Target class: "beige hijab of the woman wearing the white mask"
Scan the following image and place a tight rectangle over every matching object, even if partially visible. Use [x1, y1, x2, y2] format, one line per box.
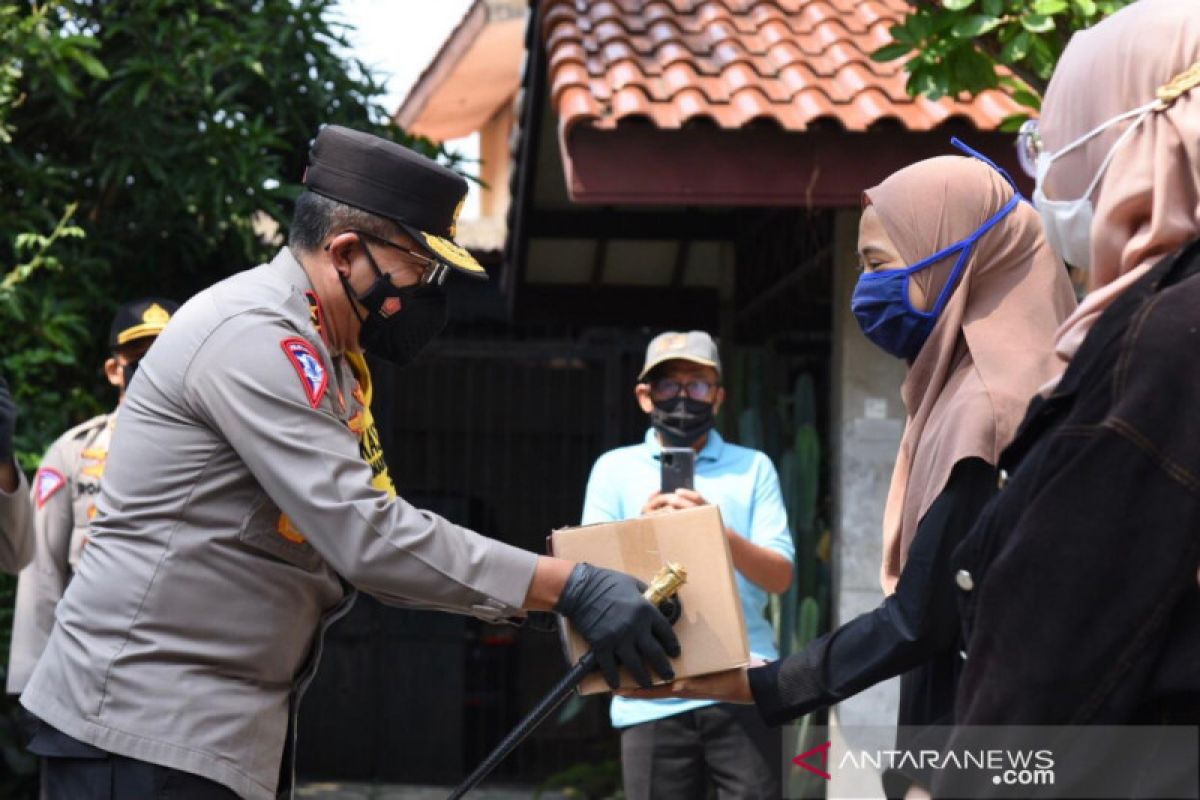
[1039, 0, 1200, 383]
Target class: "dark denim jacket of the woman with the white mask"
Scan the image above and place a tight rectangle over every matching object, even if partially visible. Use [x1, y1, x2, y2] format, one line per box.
[953, 240, 1200, 726]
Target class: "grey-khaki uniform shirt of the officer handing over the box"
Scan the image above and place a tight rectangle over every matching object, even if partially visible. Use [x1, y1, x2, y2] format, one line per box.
[22, 248, 536, 800]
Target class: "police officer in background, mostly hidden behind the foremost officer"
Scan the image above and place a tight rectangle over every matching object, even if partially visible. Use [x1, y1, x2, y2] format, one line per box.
[2, 297, 179, 694]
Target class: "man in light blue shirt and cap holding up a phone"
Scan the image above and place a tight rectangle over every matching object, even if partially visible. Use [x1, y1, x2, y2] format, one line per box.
[583, 331, 794, 800]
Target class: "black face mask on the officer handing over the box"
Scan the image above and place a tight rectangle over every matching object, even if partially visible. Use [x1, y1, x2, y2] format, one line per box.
[341, 239, 446, 367]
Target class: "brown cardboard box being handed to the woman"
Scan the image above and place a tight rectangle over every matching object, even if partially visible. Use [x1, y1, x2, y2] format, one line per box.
[550, 506, 750, 694]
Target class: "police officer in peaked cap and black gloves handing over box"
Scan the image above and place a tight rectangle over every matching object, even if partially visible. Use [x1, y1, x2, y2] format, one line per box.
[20, 127, 678, 800]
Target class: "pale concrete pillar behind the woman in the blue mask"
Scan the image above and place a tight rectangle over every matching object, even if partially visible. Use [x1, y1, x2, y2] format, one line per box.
[828, 210, 905, 798]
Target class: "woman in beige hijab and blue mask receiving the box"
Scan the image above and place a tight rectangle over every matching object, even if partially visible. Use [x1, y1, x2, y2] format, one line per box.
[632, 143, 1075, 795]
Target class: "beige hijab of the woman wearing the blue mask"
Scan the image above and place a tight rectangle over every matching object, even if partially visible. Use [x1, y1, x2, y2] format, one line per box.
[865, 156, 1075, 594]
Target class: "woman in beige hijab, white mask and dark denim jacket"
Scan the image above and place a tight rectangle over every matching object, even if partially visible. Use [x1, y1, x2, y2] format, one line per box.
[935, 0, 1200, 796]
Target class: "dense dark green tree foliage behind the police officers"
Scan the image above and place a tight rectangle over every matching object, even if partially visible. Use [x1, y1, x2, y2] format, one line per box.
[0, 0, 452, 468]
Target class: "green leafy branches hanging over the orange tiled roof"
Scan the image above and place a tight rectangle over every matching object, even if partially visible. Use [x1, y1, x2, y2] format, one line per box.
[871, 0, 1133, 128]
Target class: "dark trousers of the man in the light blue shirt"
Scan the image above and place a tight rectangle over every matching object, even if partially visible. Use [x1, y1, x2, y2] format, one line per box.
[620, 703, 782, 800]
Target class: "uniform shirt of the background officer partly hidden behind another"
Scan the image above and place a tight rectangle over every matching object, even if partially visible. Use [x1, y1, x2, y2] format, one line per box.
[7, 414, 116, 694]
